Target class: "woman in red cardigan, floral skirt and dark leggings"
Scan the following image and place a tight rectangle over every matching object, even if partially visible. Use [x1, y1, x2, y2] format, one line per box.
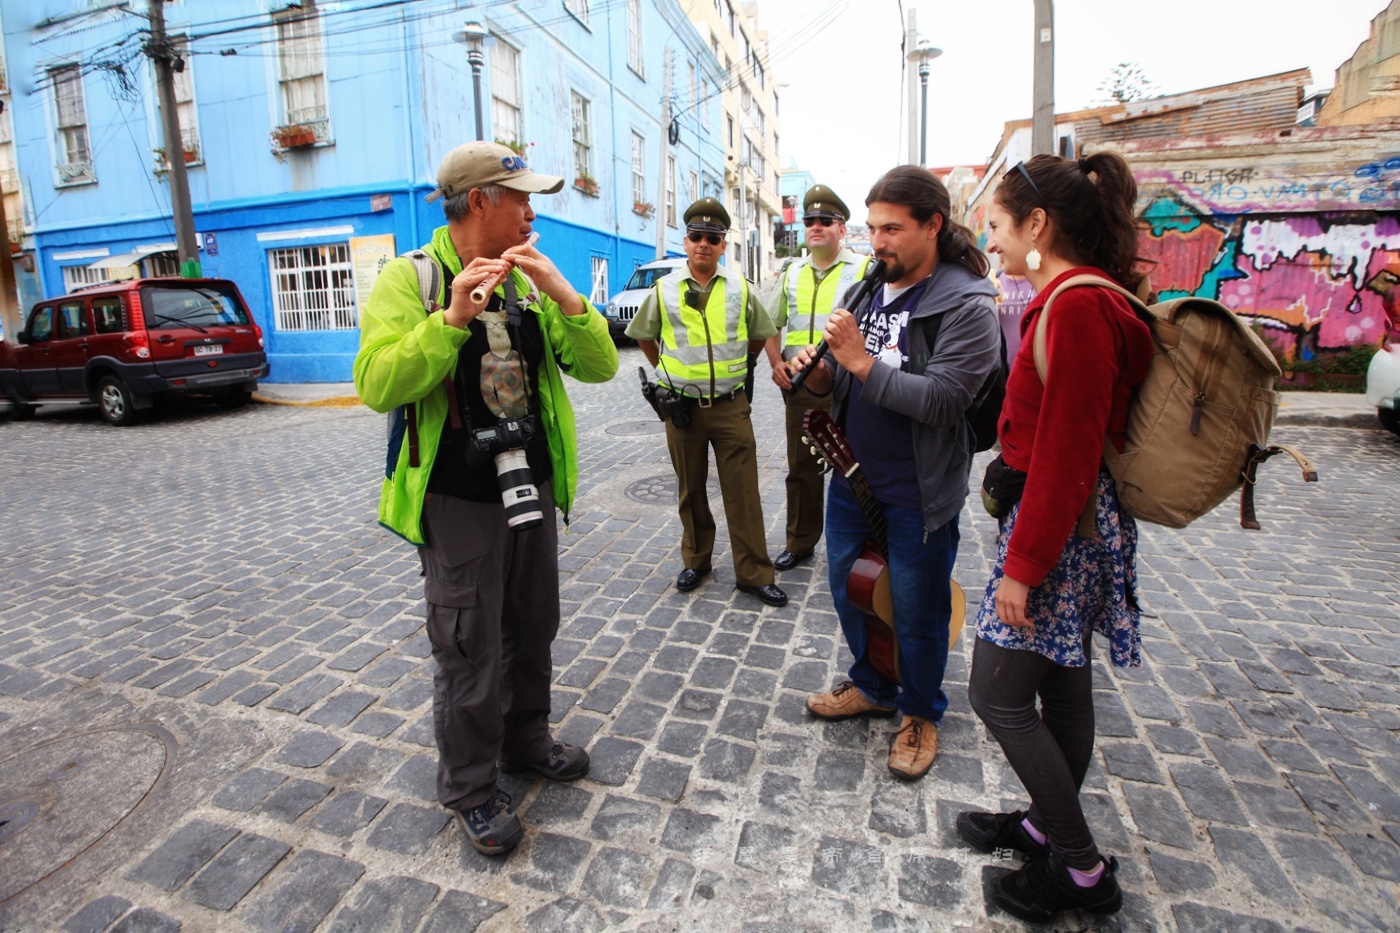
[958, 151, 1152, 922]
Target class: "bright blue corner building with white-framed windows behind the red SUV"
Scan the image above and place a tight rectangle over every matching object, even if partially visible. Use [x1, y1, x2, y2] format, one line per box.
[8, 0, 725, 382]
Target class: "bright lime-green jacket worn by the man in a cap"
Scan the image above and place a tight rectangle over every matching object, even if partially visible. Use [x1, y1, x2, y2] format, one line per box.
[354, 227, 617, 545]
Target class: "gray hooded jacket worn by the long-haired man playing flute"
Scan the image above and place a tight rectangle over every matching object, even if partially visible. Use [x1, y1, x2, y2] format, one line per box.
[832, 262, 1001, 531]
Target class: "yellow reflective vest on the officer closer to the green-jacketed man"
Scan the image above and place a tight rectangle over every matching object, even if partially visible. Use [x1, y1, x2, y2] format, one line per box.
[657, 266, 749, 398]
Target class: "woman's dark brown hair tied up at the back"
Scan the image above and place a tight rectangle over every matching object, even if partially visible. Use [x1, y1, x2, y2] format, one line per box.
[994, 150, 1151, 291]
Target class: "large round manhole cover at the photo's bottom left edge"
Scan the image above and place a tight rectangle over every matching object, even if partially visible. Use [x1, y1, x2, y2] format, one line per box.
[0, 727, 175, 902]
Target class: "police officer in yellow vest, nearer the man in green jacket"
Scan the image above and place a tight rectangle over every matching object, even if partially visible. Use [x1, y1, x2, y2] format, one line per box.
[627, 198, 787, 605]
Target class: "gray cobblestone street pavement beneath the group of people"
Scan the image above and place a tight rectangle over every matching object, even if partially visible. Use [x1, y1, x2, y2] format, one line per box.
[0, 349, 1400, 933]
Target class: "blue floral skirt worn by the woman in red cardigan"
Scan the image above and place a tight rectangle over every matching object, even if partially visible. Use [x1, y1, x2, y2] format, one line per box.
[977, 468, 1142, 667]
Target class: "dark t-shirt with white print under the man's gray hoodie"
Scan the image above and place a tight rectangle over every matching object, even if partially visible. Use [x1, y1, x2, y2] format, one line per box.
[837, 279, 928, 509]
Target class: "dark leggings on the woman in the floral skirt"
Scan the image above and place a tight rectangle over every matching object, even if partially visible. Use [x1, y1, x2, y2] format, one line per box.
[967, 639, 1100, 871]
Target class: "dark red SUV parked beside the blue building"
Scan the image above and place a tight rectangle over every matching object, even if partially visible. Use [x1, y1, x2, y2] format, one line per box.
[0, 279, 267, 426]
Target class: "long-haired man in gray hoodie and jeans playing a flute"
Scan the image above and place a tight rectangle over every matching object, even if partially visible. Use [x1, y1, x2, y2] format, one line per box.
[790, 165, 1001, 780]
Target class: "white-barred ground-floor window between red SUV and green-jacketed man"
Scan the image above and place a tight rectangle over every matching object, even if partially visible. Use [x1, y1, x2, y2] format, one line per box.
[267, 242, 360, 331]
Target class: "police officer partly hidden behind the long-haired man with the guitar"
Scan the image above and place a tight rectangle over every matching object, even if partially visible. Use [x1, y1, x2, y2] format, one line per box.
[767, 185, 869, 570]
